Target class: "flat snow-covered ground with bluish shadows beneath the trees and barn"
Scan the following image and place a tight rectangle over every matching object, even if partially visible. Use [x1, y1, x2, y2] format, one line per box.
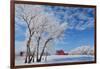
[15, 55, 94, 65]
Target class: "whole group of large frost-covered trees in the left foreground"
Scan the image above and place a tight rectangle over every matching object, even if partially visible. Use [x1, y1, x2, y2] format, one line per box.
[15, 4, 67, 63]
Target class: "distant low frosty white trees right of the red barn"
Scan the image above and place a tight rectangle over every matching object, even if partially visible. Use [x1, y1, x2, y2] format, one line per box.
[69, 46, 94, 55]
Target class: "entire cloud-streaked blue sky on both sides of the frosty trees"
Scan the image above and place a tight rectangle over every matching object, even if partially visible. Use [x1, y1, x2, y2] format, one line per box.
[15, 5, 95, 51]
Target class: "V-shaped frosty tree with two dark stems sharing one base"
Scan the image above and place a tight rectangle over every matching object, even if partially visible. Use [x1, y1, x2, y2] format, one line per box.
[28, 13, 67, 62]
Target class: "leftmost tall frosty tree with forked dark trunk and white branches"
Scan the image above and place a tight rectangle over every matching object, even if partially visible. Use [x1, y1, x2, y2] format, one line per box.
[15, 4, 43, 63]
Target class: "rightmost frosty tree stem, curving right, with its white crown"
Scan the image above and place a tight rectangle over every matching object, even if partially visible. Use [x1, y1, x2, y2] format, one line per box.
[39, 22, 67, 61]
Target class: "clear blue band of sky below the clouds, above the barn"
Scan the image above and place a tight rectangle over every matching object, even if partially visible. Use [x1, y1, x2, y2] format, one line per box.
[56, 29, 94, 51]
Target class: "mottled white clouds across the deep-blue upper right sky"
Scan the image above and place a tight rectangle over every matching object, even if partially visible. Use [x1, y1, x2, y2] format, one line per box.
[47, 6, 94, 30]
